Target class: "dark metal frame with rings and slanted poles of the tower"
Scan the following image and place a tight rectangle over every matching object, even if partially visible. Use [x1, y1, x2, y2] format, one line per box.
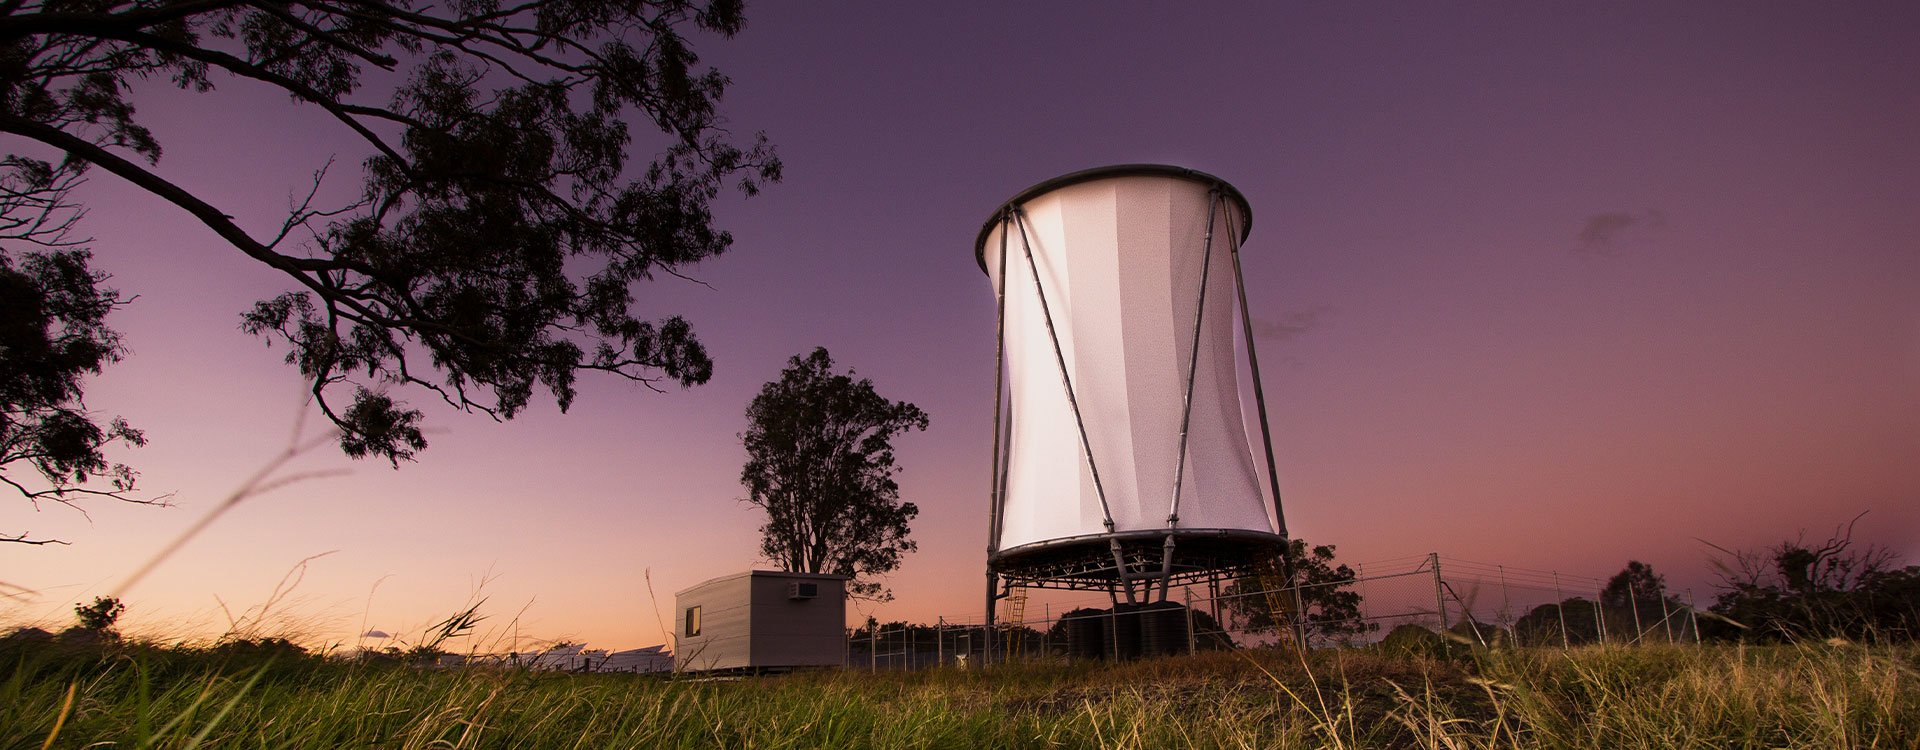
[973, 165, 1292, 640]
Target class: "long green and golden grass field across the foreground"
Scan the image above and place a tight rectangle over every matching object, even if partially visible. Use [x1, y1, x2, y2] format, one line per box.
[0, 641, 1920, 748]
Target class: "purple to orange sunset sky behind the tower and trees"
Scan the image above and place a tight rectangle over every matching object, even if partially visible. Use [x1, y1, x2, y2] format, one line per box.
[0, 2, 1920, 648]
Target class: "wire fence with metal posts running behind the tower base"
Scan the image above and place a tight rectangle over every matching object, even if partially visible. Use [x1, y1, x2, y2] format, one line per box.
[847, 554, 1699, 669]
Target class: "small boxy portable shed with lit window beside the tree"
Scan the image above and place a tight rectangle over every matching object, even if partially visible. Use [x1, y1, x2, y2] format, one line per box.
[674, 570, 847, 671]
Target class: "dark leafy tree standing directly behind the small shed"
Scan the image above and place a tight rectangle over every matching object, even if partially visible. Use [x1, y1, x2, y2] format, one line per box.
[739, 349, 927, 598]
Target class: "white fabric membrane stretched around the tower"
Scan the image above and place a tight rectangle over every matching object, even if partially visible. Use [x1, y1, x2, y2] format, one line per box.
[981, 175, 1273, 551]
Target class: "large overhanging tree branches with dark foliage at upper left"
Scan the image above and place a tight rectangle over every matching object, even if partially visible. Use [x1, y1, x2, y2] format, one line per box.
[0, 0, 780, 466]
